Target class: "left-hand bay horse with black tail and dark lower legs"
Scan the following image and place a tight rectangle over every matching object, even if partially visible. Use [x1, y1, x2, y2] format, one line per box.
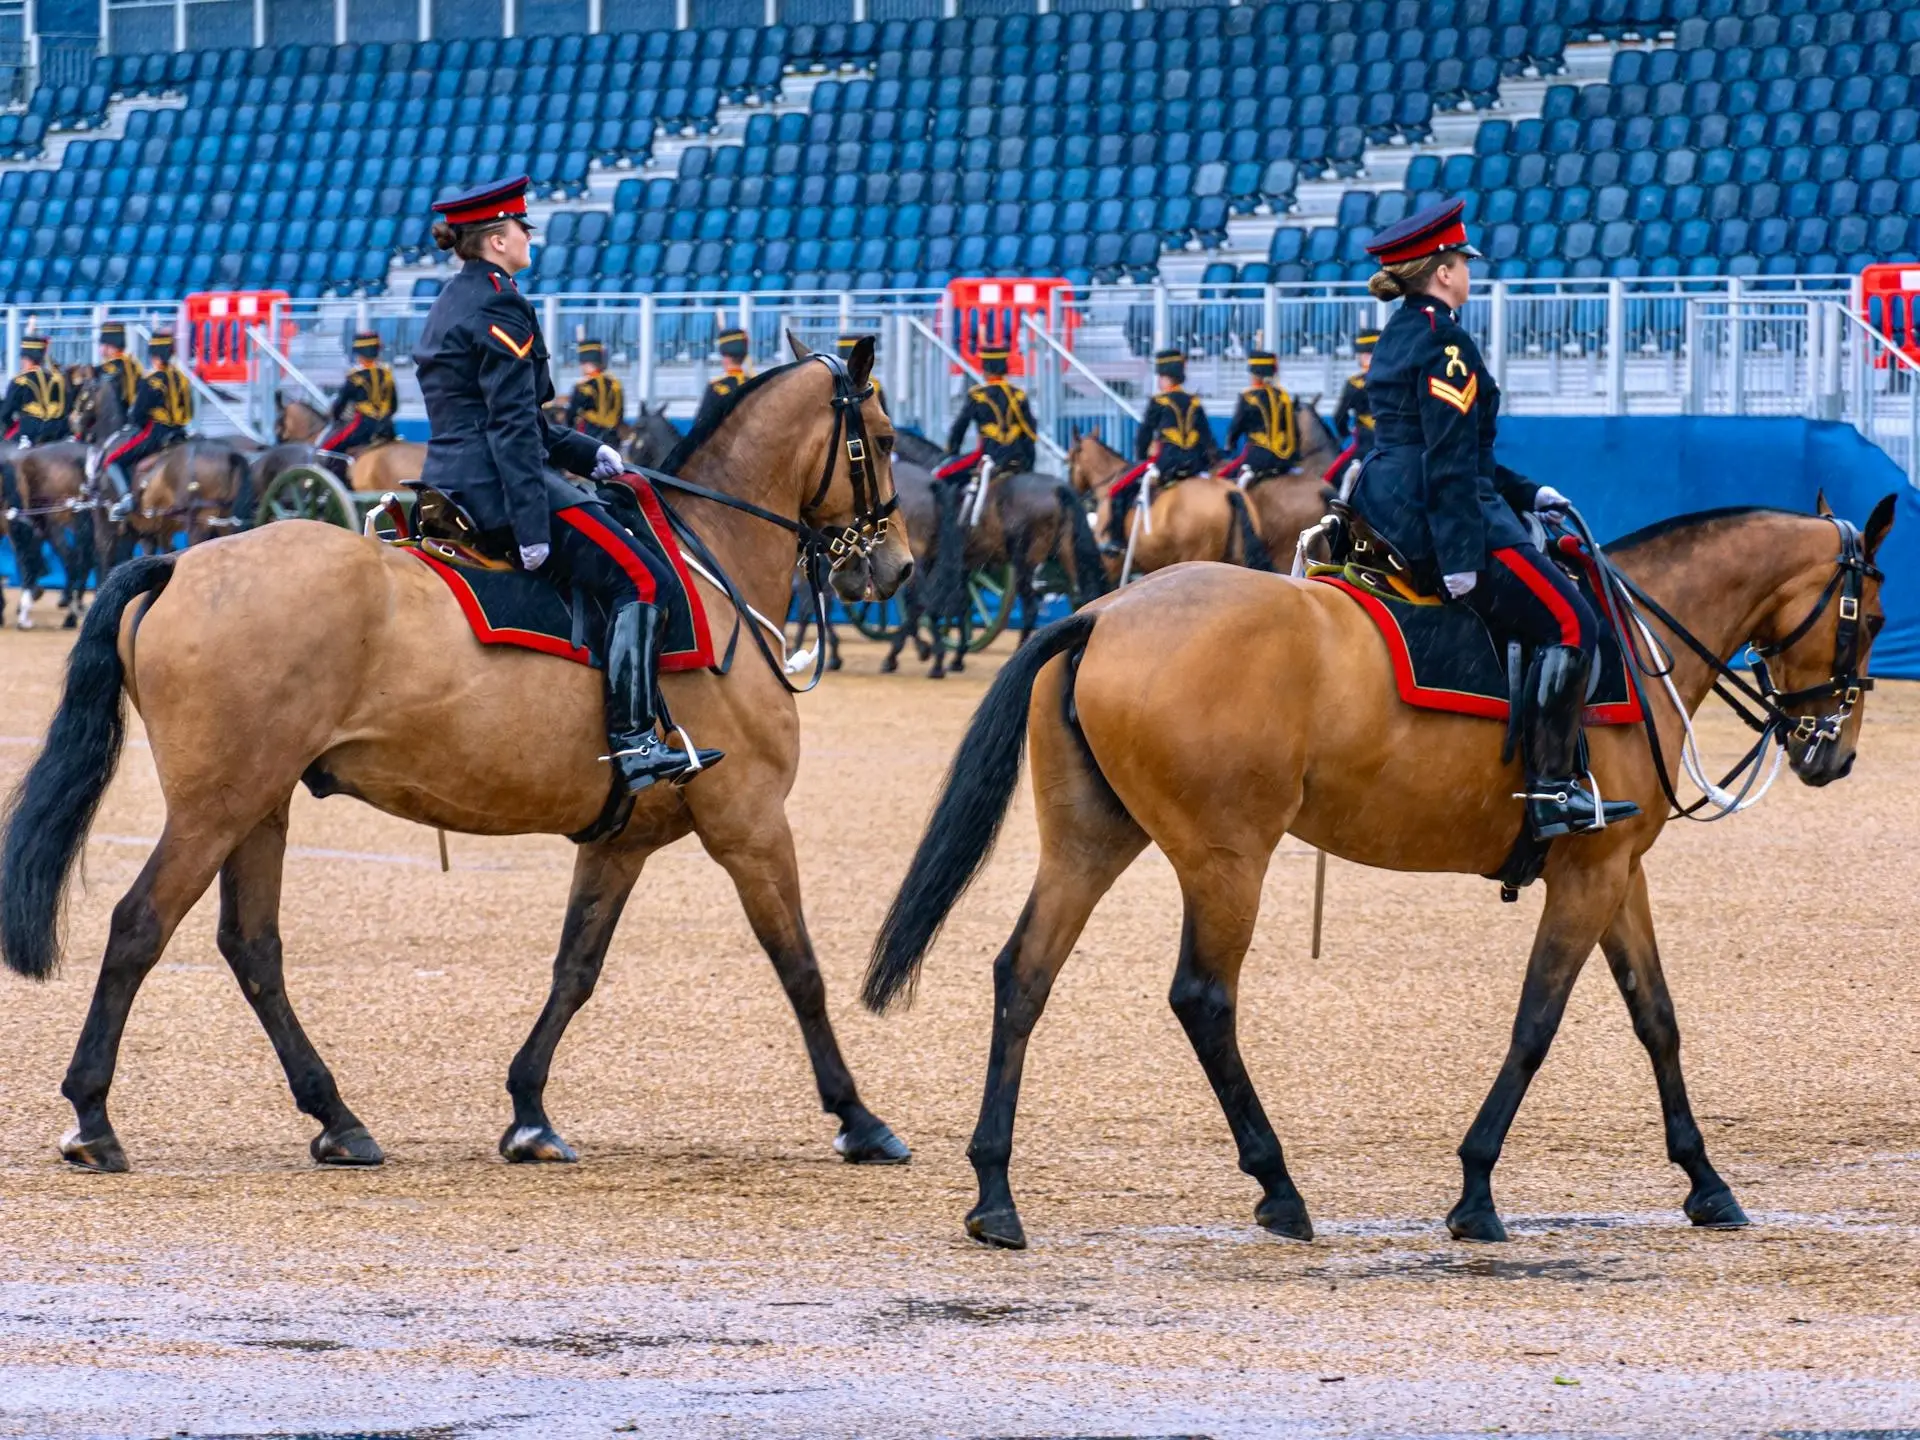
[0, 342, 910, 1171]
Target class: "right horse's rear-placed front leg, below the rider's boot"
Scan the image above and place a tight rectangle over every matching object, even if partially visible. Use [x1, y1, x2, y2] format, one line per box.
[1446, 856, 1626, 1240]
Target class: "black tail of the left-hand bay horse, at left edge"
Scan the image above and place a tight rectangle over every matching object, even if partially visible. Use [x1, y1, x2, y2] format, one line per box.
[0, 555, 173, 979]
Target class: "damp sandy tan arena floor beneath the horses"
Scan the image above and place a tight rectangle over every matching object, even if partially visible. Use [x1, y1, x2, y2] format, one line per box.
[0, 632, 1920, 1440]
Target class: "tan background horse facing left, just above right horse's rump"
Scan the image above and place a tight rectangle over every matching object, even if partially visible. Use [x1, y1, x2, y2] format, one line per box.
[1068, 432, 1274, 580]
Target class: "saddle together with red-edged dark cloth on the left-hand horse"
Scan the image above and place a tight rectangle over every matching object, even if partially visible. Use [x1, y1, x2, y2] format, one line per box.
[380, 478, 716, 674]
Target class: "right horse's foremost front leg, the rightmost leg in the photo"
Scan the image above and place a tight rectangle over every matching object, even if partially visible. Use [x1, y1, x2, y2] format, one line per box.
[1599, 866, 1747, 1229]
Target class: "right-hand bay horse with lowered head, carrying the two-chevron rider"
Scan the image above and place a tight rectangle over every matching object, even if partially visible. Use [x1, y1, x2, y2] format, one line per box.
[862, 495, 1893, 1248]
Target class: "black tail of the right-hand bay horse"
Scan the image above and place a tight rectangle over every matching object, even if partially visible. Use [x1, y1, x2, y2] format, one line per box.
[860, 612, 1094, 1012]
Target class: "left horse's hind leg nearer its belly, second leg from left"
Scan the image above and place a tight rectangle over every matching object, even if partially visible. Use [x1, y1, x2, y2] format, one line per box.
[219, 804, 386, 1165]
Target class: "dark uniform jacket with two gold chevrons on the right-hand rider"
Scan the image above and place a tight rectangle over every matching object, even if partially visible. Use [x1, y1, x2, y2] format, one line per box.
[1354, 296, 1538, 576]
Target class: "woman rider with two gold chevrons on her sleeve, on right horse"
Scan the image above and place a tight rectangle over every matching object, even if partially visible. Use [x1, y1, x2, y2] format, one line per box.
[1352, 200, 1640, 839]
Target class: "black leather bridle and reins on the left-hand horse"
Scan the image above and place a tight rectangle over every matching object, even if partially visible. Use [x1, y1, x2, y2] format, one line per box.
[632, 353, 900, 695]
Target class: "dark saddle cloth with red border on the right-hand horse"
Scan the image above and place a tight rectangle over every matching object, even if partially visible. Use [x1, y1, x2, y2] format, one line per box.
[1313, 536, 1642, 726]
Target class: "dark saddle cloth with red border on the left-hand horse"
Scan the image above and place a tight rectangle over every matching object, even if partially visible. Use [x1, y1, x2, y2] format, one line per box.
[403, 476, 714, 674]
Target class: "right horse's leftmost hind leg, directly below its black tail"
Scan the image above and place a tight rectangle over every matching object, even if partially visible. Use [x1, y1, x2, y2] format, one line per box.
[966, 814, 1146, 1250]
